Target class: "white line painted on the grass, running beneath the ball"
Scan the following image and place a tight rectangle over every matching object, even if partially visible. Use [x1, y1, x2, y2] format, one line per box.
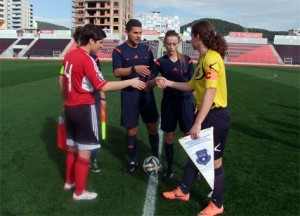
[143, 119, 163, 216]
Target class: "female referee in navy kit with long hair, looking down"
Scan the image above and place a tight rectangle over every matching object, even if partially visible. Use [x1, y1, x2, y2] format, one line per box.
[150, 30, 194, 180]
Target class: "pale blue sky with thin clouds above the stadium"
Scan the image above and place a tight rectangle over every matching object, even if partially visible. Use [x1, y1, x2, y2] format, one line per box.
[28, 0, 300, 31]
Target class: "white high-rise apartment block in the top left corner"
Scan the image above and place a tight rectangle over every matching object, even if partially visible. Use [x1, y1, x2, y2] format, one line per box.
[0, 0, 33, 31]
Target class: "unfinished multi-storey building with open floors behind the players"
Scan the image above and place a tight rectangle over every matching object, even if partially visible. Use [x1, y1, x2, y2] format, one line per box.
[73, 0, 134, 39]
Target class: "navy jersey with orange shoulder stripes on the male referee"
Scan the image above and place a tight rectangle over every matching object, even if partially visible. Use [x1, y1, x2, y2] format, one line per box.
[112, 42, 154, 81]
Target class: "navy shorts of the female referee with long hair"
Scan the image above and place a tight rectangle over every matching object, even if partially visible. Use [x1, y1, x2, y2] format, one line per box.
[161, 97, 195, 133]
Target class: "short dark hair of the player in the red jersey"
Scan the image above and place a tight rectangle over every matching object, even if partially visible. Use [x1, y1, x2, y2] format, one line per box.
[80, 23, 106, 46]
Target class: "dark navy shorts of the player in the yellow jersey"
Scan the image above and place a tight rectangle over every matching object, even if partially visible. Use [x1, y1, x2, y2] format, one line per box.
[201, 108, 230, 160]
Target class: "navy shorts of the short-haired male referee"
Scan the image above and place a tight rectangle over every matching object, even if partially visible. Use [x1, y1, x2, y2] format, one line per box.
[121, 88, 158, 128]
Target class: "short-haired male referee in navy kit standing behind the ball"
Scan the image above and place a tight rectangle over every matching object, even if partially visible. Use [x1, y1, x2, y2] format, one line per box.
[112, 19, 159, 174]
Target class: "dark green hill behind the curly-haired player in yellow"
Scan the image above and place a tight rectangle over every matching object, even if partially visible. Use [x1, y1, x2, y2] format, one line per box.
[180, 18, 288, 42]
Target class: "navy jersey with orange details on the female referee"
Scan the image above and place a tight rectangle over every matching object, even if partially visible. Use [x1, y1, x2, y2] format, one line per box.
[151, 55, 194, 99]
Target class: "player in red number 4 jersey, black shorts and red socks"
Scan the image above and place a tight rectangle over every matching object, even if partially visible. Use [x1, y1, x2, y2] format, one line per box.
[62, 24, 146, 200]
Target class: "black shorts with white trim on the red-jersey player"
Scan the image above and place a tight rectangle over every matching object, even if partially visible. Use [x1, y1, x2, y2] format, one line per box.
[65, 104, 100, 150]
